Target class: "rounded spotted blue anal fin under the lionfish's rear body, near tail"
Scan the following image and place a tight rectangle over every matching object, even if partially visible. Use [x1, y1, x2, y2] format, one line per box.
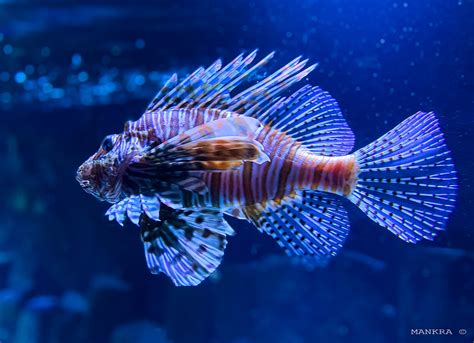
[243, 191, 349, 259]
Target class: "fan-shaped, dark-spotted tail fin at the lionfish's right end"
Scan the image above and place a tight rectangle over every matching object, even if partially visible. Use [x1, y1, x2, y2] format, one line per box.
[349, 112, 457, 243]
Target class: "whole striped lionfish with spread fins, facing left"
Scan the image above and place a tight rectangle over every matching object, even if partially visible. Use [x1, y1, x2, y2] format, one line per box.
[77, 51, 457, 286]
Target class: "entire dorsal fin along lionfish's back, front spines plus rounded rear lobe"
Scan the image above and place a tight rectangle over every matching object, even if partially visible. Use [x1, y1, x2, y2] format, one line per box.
[147, 51, 354, 156]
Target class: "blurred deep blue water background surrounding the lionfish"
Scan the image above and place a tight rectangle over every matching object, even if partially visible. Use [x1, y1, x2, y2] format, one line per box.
[0, 0, 474, 343]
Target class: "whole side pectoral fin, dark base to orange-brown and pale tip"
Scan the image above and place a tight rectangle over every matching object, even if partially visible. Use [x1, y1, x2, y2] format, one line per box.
[126, 117, 269, 200]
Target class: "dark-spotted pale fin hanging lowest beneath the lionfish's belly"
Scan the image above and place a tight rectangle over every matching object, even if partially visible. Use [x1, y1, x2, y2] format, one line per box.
[140, 206, 234, 286]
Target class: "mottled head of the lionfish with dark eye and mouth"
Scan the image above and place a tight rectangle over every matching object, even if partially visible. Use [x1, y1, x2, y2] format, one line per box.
[76, 135, 130, 203]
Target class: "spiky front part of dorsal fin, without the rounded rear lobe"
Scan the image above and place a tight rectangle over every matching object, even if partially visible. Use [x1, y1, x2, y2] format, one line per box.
[147, 50, 315, 116]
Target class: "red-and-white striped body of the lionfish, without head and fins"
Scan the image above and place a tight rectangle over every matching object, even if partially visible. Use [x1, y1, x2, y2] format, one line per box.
[126, 109, 357, 209]
